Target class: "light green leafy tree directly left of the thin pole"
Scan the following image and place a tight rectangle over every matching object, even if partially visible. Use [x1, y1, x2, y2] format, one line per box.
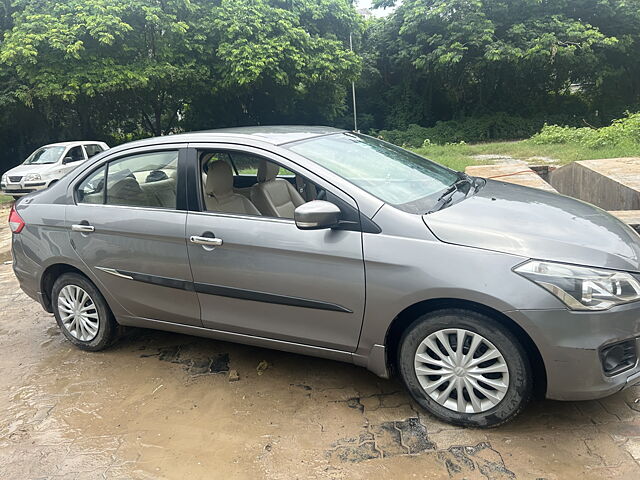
[182, 0, 360, 128]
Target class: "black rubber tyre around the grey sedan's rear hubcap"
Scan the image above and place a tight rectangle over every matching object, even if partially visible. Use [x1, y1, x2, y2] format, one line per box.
[51, 273, 118, 352]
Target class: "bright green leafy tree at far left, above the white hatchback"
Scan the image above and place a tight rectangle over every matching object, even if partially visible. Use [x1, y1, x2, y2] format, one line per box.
[0, 0, 208, 136]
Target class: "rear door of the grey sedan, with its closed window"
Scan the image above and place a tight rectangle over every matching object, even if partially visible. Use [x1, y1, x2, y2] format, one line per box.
[66, 145, 201, 326]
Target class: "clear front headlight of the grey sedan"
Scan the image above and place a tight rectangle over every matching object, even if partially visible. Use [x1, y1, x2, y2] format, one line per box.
[513, 260, 640, 310]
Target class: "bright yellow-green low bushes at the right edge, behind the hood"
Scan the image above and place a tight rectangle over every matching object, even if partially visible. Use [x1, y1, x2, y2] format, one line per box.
[531, 112, 640, 149]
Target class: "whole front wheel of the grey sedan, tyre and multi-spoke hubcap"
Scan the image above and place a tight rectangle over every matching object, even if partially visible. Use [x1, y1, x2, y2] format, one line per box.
[398, 309, 532, 427]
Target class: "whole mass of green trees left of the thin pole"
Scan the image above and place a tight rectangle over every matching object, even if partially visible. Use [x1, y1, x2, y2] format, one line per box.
[0, 0, 362, 171]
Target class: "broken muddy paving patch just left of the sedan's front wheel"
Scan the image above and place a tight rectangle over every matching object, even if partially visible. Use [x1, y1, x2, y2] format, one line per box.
[326, 418, 436, 462]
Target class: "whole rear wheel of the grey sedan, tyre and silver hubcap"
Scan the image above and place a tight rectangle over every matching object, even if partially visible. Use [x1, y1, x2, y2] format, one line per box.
[51, 273, 118, 351]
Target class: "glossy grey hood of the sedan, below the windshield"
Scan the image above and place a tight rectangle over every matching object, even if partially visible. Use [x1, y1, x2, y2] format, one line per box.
[423, 180, 640, 271]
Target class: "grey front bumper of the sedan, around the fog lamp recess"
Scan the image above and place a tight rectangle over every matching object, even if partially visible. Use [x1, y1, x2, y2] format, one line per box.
[505, 303, 640, 400]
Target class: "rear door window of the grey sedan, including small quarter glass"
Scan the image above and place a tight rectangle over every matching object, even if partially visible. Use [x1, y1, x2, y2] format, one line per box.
[76, 151, 178, 209]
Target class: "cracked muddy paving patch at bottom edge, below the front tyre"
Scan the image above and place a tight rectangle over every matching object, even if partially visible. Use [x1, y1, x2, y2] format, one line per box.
[438, 442, 516, 480]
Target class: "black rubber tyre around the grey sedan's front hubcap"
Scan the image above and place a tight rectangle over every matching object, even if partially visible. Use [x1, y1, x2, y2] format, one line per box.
[398, 309, 533, 428]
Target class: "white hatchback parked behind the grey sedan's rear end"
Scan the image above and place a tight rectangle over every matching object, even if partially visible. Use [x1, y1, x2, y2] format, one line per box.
[0, 141, 109, 198]
